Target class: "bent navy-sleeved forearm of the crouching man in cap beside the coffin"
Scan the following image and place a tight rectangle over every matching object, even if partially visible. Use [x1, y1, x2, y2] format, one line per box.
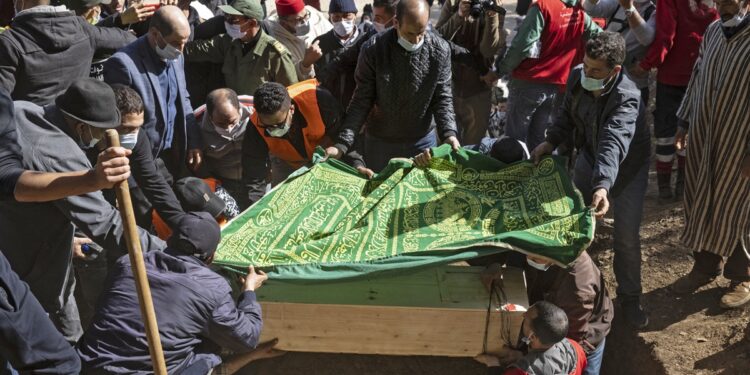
[206, 291, 263, 352]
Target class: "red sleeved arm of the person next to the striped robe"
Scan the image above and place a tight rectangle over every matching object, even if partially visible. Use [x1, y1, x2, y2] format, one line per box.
[640, 0, 677, 71]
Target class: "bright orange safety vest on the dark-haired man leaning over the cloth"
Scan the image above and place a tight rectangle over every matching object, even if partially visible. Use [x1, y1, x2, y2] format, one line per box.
[250, 79, 326, 168]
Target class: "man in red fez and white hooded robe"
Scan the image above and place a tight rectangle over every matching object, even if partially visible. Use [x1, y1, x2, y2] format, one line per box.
[263, 0, 333, 81]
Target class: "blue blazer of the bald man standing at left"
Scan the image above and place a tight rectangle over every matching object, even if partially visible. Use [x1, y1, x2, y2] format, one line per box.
[104, 35, 201, 159]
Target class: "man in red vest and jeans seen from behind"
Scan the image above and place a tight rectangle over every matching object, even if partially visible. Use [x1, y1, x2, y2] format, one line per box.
[486, 0, 601, 149]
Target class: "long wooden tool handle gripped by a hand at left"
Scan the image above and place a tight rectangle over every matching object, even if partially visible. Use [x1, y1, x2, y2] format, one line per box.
[106, 129, 167, 375]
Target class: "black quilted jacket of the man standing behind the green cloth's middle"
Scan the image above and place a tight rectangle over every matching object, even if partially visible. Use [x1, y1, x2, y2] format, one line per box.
[336, 29, 456, 151]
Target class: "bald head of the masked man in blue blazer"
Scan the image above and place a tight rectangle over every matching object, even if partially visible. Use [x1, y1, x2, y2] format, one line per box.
[148, 5, 190, 51]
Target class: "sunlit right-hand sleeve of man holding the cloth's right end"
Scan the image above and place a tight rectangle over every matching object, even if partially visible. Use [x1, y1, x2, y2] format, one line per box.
[591, 92, 640, 191]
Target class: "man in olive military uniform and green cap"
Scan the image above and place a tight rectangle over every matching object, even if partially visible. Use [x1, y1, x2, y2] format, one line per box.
[185, 0, 297, 95]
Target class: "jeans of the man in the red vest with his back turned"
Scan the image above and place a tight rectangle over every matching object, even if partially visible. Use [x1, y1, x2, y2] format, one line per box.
[505, 80, 559, 151]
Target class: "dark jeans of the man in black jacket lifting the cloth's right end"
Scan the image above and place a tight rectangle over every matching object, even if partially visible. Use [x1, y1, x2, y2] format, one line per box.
[573, 152, 649, 298]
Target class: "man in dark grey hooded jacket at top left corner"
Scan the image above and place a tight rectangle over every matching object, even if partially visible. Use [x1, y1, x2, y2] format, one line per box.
[0, 0, 135, 105]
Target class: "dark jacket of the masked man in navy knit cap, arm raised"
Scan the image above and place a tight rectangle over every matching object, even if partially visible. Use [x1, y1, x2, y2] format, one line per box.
[313, 27, 374, 108]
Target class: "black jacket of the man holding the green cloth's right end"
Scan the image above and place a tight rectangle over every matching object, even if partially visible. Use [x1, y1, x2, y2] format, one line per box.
[547, 65, 651, 195]
